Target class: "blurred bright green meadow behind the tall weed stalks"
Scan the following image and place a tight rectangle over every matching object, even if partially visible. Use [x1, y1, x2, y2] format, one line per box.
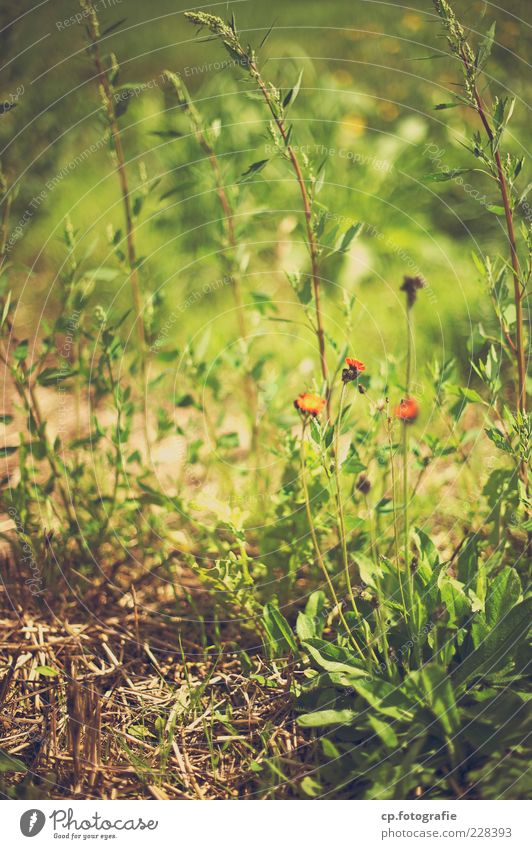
[0, 0, 532, 384]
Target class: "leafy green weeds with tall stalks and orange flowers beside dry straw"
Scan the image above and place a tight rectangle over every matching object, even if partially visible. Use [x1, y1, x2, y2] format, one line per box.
[0, 0, 532, 799]
